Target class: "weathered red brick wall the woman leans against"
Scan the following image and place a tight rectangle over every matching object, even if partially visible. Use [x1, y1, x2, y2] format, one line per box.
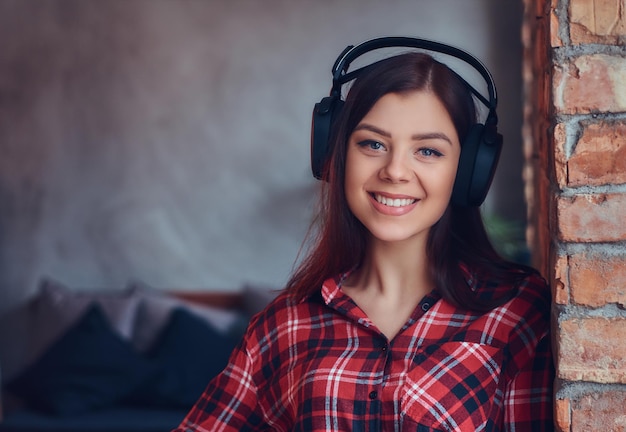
[522, 0, 626, 432]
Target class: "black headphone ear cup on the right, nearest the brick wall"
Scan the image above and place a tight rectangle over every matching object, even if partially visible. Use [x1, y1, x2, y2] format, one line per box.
[452, 123, 502, 207]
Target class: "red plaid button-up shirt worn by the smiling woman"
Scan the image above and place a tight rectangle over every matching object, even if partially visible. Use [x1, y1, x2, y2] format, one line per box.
[175, 268, 554, 432]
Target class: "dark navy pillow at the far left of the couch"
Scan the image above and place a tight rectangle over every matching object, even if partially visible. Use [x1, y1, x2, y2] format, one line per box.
[8, 304, 154, 416]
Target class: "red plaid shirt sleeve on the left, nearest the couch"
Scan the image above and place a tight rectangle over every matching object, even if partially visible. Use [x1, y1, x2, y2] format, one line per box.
[172, 339, 262, 432]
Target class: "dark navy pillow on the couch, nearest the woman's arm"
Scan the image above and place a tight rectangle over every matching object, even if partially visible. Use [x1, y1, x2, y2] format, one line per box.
[131, 308, 239, 409]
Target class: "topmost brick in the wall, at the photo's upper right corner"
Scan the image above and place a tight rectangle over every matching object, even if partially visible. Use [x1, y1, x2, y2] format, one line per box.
[569, 0, 626, 45]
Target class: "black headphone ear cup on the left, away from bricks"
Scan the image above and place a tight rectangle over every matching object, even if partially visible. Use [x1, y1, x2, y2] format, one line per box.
[311, 95, 344, 180]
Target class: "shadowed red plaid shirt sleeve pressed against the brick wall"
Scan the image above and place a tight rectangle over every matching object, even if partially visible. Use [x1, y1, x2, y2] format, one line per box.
[504, 318, 555, 432]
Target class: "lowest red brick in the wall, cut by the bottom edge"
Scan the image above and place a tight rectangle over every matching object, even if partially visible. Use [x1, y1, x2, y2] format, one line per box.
[571, 391, 626, 432]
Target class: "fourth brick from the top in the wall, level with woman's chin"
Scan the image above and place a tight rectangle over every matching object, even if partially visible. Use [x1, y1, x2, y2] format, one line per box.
[557, 193, 626, 242]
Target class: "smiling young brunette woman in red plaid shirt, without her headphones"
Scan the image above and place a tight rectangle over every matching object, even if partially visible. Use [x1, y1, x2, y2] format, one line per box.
[176, 38, 553, 432]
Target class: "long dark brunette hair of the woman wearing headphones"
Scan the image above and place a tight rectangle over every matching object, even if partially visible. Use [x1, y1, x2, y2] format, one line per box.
[286, 52, 529, 311]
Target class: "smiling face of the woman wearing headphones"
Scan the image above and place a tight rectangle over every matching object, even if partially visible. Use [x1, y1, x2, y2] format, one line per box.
[345, 91, 461, 244]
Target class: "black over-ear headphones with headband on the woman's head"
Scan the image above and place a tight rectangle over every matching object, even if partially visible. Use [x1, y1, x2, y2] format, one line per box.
[311, 37, 502, 206]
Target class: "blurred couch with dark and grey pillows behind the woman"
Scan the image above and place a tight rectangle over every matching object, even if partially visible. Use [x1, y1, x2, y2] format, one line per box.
[0, 279, 275, 432]
